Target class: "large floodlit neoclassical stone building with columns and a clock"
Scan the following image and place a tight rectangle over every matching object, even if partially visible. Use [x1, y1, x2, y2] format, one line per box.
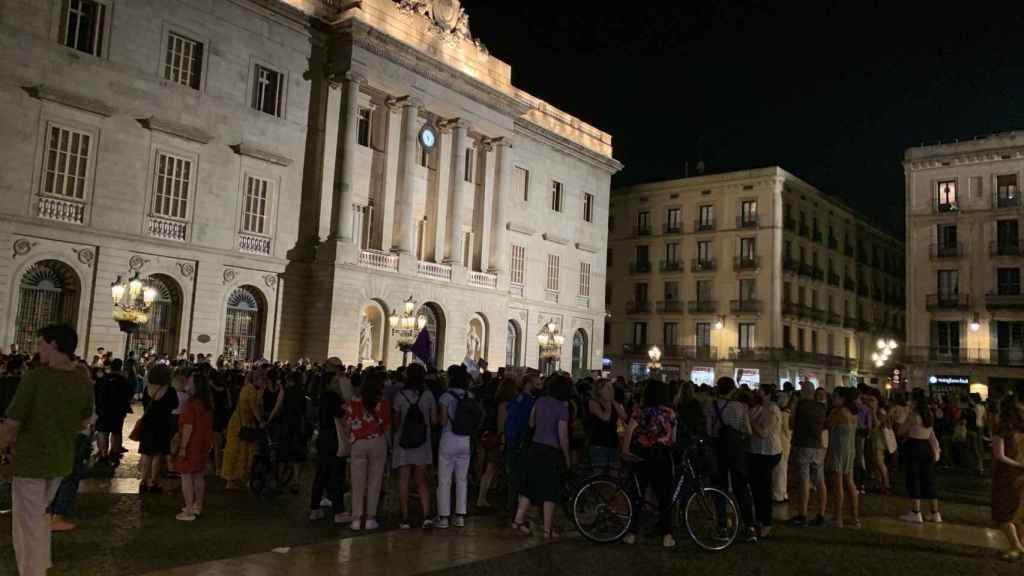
[0, 0, 621, 368]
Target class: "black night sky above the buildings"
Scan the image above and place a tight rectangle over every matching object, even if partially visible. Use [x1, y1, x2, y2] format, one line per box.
[463, 0, 1024, 233]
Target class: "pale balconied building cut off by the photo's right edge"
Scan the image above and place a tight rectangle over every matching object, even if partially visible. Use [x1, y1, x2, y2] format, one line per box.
[903, 132, 1024, 396]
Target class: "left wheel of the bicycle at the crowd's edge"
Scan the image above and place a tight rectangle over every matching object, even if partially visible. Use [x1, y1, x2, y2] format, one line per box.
[571, 479, 633, 544]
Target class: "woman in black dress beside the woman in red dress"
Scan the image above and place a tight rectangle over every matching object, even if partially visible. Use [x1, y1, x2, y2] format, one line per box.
[138, 364, 178, 494]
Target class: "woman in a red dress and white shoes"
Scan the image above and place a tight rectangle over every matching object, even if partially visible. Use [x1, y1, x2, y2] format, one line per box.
[175, 371, 213, 522]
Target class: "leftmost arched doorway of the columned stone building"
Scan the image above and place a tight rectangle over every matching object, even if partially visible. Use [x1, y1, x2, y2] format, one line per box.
[14, 260, 81, 354]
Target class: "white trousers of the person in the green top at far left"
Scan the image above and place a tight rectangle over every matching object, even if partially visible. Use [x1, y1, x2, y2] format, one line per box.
[11, 477, 60, 576]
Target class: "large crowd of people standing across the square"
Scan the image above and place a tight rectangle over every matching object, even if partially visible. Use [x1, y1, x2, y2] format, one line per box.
[0, 327, 1024, 574]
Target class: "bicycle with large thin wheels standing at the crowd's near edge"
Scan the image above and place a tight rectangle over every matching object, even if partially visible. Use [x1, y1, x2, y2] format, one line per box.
[570, 443, 741, 551]
